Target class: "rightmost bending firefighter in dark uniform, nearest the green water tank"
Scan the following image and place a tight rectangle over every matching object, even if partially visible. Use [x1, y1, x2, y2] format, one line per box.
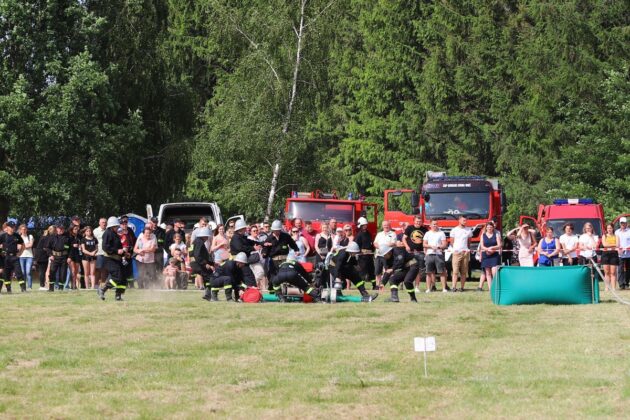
[381, 242, 420, 303]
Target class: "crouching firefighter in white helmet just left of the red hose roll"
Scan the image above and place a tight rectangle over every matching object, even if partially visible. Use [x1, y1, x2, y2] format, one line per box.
[210, 252, 256, 302]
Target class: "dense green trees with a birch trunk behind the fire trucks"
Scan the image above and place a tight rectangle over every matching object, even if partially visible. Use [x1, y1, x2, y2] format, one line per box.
[0, 0, 630, 222]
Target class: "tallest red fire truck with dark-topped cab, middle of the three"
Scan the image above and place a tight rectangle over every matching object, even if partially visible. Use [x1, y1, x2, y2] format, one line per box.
[384, 171, 506, 242]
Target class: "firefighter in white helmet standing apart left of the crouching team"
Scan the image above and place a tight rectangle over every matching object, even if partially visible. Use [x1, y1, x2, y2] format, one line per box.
[97, 216, 129, 301]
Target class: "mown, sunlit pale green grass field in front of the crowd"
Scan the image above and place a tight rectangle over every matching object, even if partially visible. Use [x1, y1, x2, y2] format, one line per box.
[0, 290, 630, 418]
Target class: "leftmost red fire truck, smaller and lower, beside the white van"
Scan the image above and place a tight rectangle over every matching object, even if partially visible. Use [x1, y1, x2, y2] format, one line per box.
[284, 190, 378, 237]
